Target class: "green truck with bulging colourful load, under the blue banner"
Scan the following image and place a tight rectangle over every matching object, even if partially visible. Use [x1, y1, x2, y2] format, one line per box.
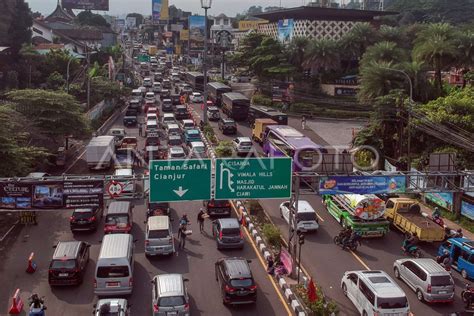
[323, 194, 390, 237]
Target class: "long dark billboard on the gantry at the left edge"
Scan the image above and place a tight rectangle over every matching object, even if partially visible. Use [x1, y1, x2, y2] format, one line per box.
[0, 180, 104, 210]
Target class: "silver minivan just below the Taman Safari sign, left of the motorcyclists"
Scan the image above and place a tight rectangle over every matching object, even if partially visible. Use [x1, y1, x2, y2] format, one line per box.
[145, 215, 175, 256]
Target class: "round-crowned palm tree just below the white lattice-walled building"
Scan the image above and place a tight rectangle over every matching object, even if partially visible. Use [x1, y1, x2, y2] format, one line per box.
[303, 39, 341, 80]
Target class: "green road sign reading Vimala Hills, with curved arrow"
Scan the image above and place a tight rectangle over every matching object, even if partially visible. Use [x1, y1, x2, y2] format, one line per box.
[215, 158, 292, 199]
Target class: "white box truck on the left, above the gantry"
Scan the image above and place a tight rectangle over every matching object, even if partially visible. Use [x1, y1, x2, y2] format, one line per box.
[86, 136, 115, 170]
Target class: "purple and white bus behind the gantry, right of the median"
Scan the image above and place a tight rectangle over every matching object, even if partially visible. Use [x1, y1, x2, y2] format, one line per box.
[262, 125, 327, 172]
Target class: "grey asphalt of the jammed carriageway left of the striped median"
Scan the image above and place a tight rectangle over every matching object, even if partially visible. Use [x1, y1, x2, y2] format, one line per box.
[0, 87, 288, 316]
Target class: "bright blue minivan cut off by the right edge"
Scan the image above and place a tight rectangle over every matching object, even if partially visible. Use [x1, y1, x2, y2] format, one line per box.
[438, 238, 474, 279]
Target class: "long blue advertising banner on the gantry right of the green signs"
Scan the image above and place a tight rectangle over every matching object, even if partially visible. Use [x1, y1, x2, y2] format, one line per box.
[319, 176, 405, 194]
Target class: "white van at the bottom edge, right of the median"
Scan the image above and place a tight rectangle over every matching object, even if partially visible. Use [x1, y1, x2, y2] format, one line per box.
[341, 270, 410, 316]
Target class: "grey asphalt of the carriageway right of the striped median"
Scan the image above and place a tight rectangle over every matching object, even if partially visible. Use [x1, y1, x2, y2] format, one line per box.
[187, 100, 465, 315]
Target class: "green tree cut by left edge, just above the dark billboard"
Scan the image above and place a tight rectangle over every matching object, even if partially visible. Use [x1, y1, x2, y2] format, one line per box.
[0, 105, 47, 177]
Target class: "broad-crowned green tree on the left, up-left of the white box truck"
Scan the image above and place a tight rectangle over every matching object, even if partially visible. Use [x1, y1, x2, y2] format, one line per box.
[6, 89, 89, 143]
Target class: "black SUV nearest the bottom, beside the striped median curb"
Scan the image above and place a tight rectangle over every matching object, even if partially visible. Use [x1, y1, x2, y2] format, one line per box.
[215, 257, 257, 304]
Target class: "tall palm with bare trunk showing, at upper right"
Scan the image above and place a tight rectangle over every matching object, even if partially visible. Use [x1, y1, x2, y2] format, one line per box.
[413, 23, 459, 93]
